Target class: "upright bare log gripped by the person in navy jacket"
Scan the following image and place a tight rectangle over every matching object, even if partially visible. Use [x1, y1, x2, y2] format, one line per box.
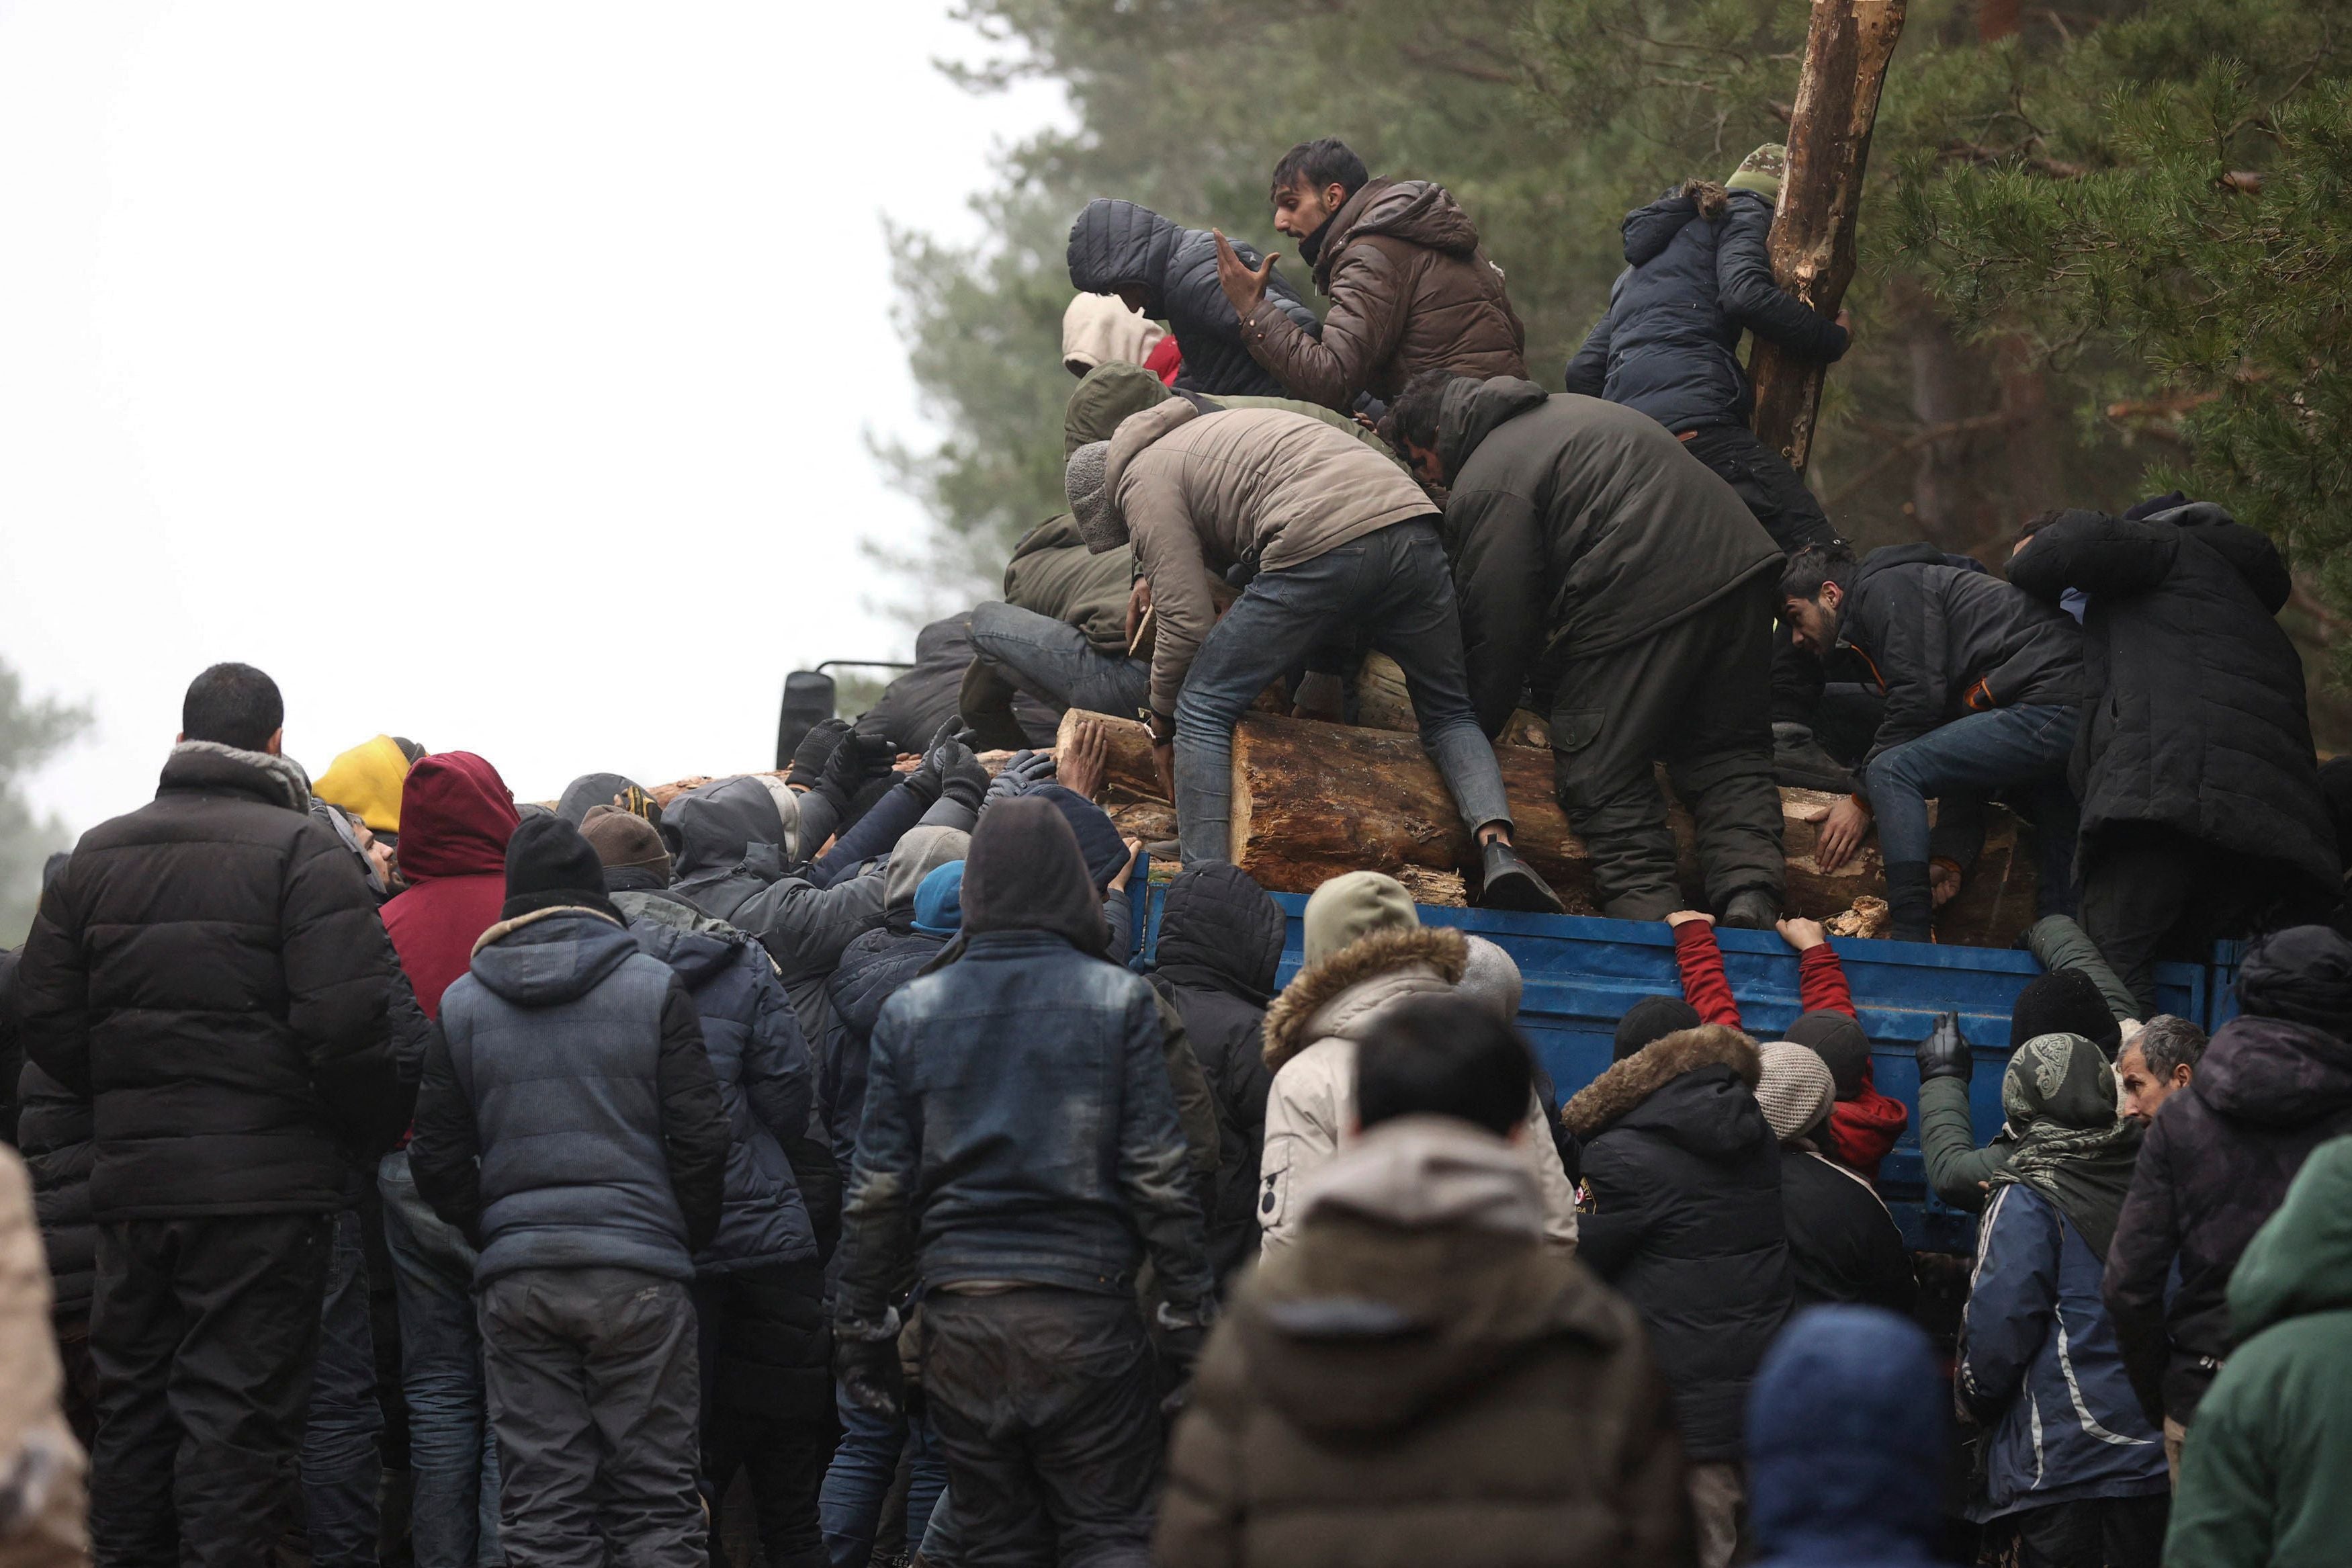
[1747, 0, 1903, 472]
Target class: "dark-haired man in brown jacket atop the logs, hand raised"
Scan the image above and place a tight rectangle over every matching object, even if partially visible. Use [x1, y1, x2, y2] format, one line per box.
[1216, 136, 1526, 409]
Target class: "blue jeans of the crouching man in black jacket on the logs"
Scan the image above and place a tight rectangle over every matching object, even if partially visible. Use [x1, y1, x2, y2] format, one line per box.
[1863, 705, 2081, 914]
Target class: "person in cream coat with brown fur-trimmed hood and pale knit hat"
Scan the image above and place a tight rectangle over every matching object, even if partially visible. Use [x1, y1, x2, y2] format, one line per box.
[1258, 872, 1576, 1251]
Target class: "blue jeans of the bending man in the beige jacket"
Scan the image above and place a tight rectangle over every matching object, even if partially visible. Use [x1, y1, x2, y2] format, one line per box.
[1176, 519, 1510, 865]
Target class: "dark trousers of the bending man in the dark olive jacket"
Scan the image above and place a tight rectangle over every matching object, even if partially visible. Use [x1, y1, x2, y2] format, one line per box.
[1553, 578, 1788, 919]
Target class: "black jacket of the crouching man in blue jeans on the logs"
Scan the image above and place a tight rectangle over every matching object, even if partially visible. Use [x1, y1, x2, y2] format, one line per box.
[1839, 546, 2091, 762]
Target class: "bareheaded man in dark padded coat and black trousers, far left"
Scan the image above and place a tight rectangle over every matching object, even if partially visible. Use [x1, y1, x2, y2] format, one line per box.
[19, 665, 407, 1566]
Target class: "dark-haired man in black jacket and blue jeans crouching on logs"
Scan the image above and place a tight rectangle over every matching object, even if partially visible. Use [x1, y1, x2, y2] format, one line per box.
[1780, 546, 2091, 943]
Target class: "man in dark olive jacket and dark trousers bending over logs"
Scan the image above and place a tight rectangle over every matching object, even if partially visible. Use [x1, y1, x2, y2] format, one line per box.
[1383, 372, 1788, 931]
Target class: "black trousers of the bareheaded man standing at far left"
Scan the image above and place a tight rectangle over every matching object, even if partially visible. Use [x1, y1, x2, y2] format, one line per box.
[89, 1213, 334, 1568]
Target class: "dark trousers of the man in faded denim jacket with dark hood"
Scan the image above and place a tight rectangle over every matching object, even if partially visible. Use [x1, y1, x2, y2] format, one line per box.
[922, 1289, 1160, 1568]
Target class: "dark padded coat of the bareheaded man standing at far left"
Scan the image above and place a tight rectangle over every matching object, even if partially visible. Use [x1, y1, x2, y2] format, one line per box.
[17, 740, 404, 1223]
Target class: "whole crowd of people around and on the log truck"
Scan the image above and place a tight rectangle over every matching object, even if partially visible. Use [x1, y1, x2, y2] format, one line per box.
[0, 141, 2352, 1568]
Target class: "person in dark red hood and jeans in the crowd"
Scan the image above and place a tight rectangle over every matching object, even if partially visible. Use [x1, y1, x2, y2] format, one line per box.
[376, 752, 520, 1568]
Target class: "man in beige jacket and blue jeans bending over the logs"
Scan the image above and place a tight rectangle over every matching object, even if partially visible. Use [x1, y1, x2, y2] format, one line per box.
[1065, 400, 1561, 914]
